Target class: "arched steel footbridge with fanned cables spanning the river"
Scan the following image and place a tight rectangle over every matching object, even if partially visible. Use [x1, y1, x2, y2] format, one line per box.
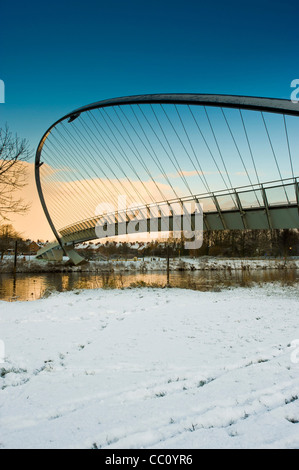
[35, 94, 299, 264]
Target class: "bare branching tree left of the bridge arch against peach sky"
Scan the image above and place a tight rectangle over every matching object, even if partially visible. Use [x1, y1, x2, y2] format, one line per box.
[0, 125, 31, 221]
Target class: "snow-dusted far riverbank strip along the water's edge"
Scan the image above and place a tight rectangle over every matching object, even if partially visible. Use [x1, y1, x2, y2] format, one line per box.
[0, 257, 299, 274]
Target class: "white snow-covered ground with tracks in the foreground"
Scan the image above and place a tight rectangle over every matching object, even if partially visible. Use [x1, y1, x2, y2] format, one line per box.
[0, 284, 299, 449]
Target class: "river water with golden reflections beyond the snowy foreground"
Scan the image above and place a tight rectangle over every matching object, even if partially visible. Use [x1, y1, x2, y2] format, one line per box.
[0, 269, 299, 302]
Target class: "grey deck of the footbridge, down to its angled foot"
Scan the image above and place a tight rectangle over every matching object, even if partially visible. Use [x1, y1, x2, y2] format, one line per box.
[37, 180, 299, 264]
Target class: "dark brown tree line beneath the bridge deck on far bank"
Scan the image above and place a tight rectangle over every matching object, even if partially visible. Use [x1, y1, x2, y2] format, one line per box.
[80, 229, 299, 259]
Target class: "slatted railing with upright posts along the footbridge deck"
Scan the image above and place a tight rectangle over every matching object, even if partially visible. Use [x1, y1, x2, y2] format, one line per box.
[59, 177, 299, 236]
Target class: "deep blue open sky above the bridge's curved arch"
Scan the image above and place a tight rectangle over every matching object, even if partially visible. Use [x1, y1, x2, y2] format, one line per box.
[0, 0, 299, 151]
